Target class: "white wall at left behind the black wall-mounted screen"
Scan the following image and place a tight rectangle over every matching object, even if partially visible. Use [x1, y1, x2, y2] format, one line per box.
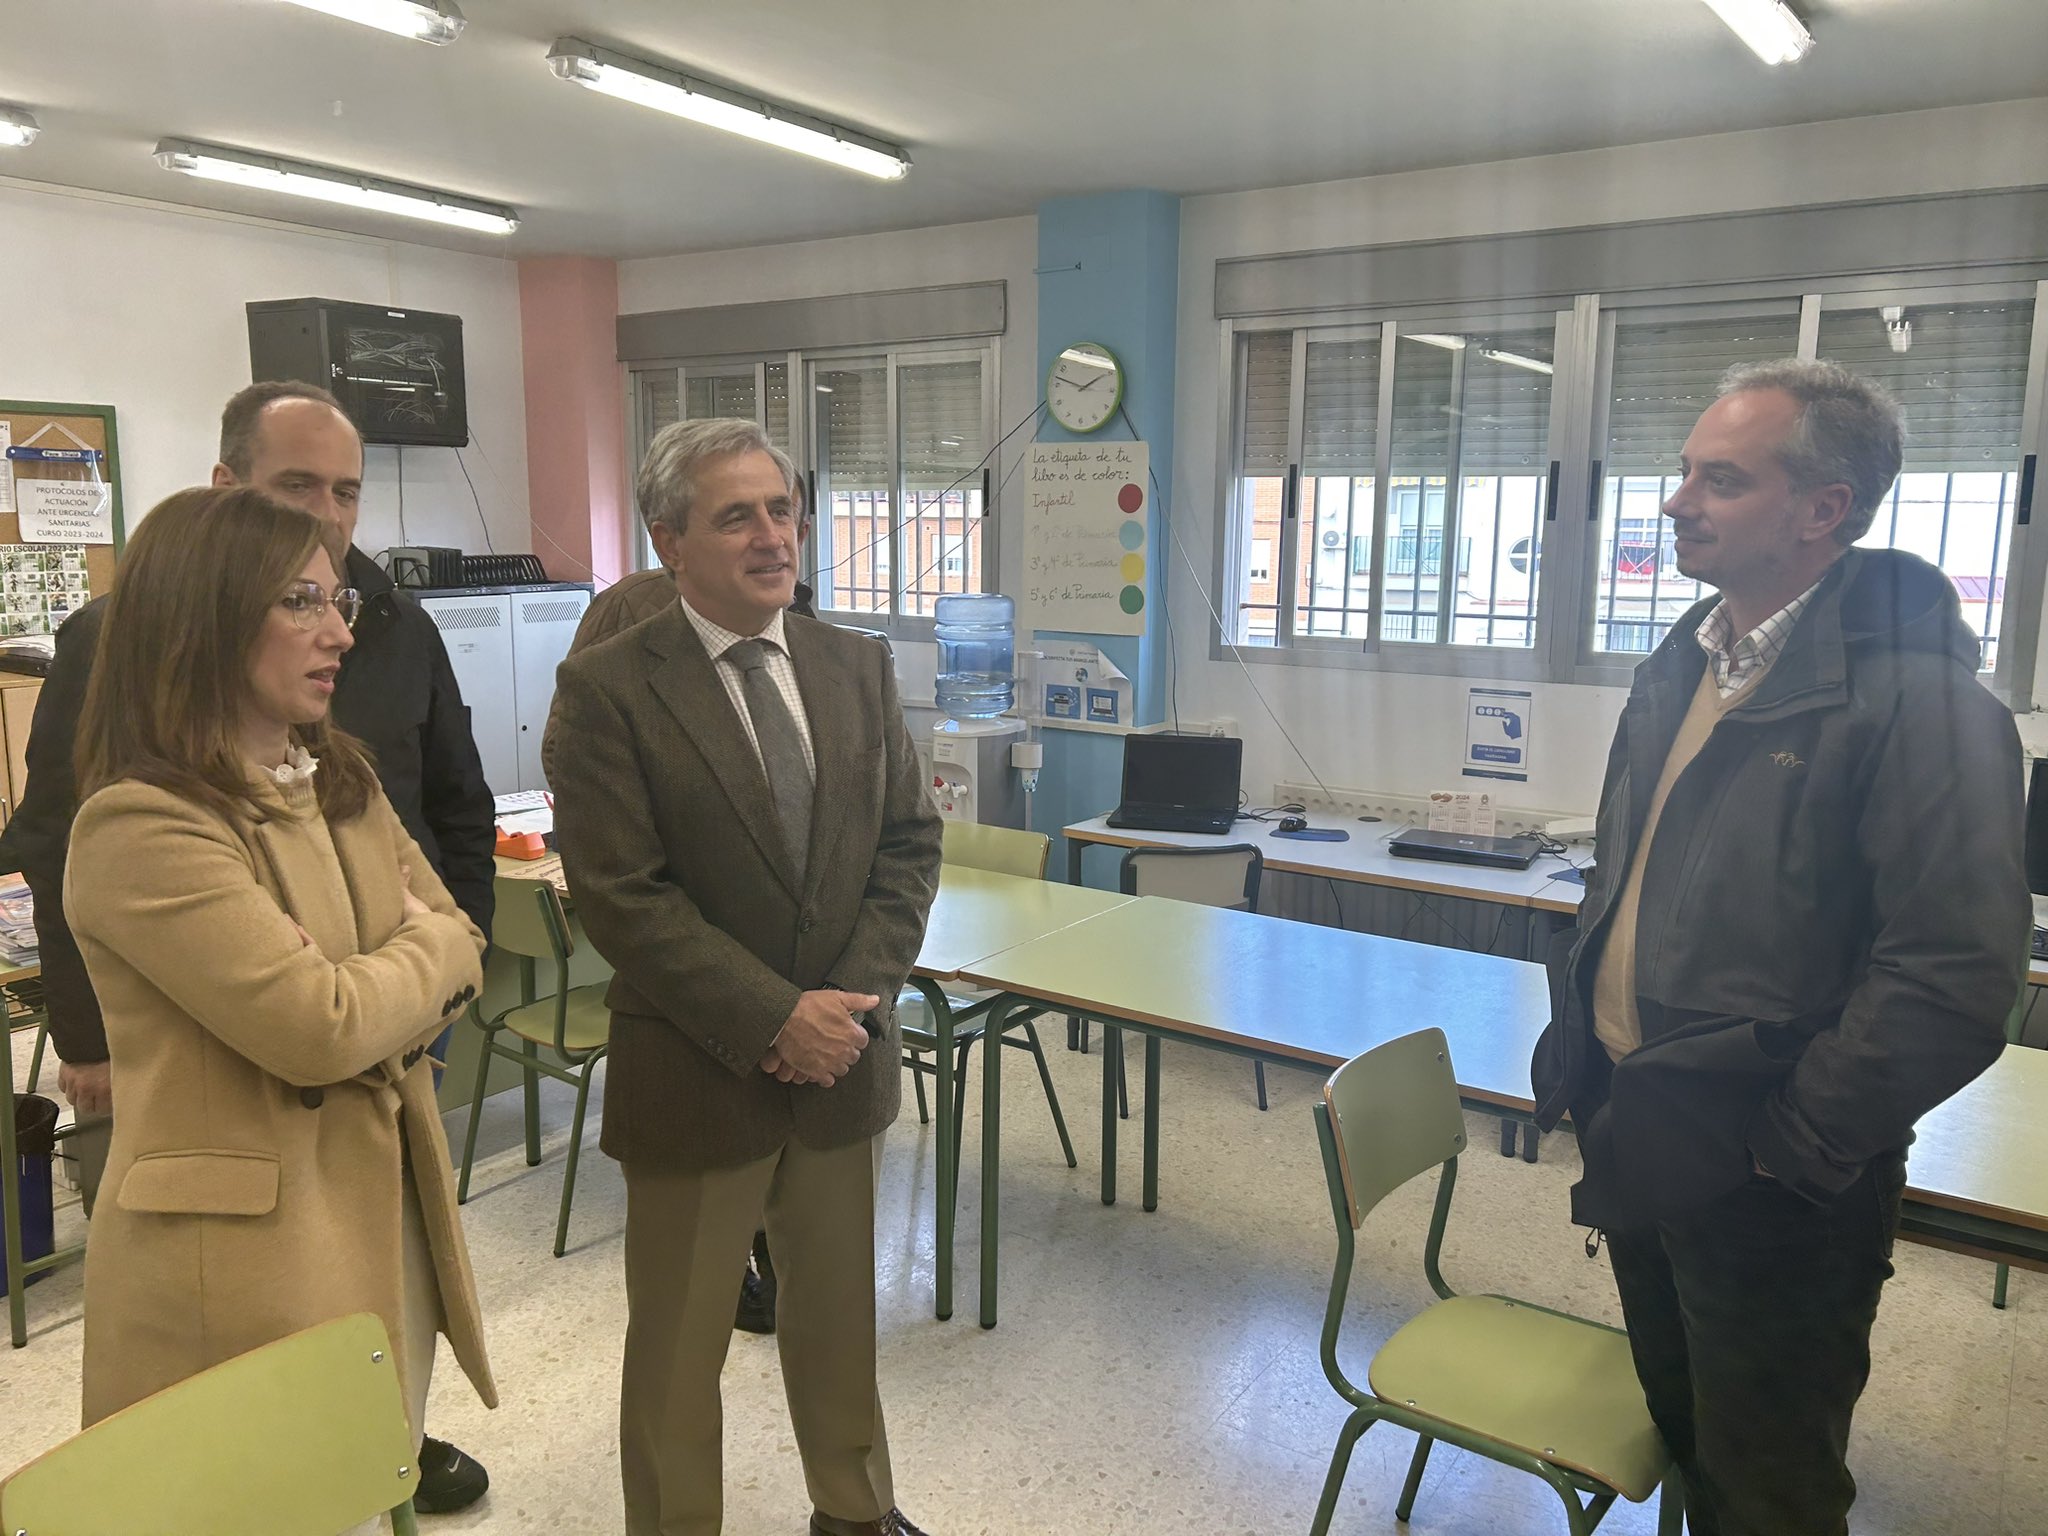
[0, 180, 532, 553]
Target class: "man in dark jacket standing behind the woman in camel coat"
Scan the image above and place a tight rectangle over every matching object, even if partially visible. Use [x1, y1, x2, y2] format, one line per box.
[0, 383, 496, 1513]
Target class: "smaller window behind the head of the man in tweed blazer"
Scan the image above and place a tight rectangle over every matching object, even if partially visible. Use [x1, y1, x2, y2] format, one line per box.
[631, 344, 995, 633]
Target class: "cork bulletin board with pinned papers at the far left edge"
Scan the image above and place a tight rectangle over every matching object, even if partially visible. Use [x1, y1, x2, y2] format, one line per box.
[0, 399, 125, 637]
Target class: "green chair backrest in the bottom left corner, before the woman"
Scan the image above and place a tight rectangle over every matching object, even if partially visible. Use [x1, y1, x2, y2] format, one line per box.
[0, 1313, 420, 1536]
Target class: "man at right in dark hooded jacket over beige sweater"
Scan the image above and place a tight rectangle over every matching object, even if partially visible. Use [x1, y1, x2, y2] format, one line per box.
[1532, 362, 2030, 1536]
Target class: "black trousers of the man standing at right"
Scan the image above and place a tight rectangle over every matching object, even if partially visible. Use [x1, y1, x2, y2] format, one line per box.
[1608, 1155, 1905, 1536]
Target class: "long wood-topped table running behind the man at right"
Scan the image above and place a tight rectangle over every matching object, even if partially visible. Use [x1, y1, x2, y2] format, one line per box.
[961, 897, 2048, 1327]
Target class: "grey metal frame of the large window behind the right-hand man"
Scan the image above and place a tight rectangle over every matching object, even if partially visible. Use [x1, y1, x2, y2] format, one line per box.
[1208, 278, 2048, 711]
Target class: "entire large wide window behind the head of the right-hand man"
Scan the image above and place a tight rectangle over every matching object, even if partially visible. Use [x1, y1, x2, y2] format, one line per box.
[1219, 279, 2048, 698]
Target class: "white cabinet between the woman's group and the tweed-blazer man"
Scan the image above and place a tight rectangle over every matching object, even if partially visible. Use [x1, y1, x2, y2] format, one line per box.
[420, 588, 590, 795]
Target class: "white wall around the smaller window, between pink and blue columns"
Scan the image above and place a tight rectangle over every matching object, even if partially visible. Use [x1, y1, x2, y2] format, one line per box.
[618, 217, 1040, 696]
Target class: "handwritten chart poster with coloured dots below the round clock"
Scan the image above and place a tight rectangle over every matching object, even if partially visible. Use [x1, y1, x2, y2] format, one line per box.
[1024, 442, 1151, 635]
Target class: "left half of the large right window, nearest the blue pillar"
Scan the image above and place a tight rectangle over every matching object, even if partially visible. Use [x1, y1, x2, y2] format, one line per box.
[1233, 315, 1556, 655]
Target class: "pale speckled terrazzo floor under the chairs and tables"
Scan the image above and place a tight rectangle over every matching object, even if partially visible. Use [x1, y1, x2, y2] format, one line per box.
[0, 1024, 2048, 1536]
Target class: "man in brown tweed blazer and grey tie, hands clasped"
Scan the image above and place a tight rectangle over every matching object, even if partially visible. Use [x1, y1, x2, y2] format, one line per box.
[555, 420, 940, 1536]
